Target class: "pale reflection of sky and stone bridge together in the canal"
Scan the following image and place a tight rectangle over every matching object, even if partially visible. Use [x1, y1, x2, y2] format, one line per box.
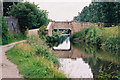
[53, 37, 93, 78]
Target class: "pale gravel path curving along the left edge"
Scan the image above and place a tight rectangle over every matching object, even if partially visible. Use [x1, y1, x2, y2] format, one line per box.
[0, 40, 25, 78]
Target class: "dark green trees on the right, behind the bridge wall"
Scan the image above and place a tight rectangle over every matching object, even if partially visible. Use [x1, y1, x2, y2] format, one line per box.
[74, 2, 120, 26]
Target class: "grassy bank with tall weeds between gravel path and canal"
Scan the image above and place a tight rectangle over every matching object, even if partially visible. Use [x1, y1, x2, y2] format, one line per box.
[7, 36, 66, 78]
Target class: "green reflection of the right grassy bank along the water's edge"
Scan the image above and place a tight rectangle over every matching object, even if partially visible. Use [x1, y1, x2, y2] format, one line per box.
[72, 44, 120, 64]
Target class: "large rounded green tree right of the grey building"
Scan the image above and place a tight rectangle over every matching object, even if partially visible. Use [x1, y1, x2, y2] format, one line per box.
[9, 2, 49, 34]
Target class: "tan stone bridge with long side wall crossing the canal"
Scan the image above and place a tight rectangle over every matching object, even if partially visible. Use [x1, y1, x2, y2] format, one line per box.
[46, 21, 103, 36]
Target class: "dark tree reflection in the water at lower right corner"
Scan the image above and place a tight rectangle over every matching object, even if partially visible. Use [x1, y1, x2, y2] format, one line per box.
[83, 58, 120, 78]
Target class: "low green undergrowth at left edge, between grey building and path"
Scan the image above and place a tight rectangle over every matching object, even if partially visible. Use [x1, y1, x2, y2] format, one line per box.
[0, 16, 26, 45]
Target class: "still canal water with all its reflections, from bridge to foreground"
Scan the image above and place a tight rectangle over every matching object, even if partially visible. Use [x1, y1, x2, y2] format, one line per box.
[53, 37, 120, 78]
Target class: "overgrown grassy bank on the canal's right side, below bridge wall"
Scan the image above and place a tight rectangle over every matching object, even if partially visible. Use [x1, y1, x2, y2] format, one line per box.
[71, 26, 120, 50]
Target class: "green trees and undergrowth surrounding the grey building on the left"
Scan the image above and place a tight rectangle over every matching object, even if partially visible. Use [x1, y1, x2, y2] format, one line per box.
[0, 2, 49, 45]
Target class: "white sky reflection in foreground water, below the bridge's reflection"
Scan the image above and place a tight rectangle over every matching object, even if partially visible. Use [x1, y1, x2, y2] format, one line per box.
[59, 58, 93, 78]
